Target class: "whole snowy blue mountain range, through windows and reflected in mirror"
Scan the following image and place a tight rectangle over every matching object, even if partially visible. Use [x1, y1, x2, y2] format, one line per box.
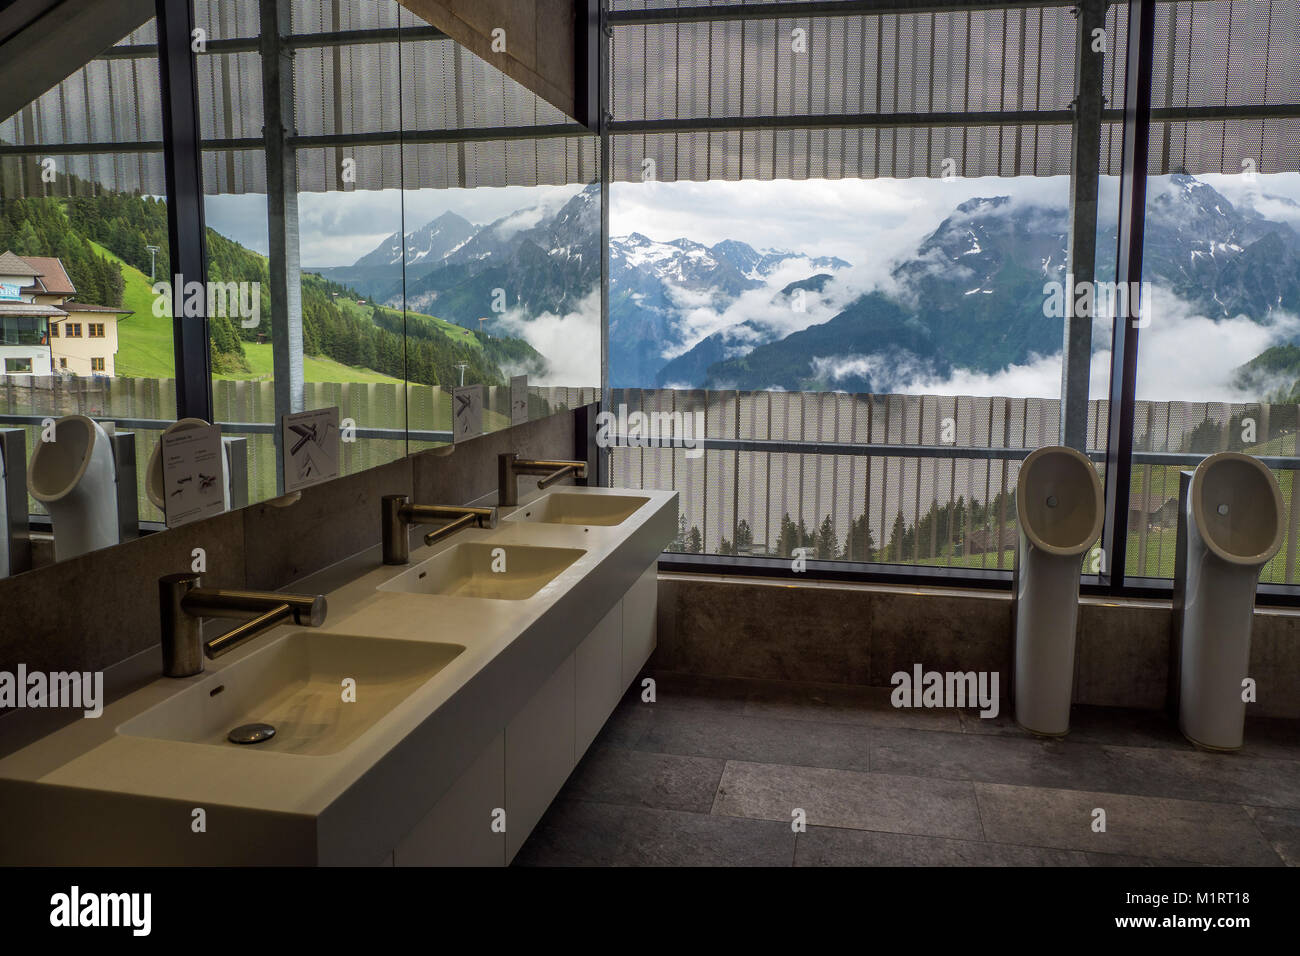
[315, 174, 1300, 392]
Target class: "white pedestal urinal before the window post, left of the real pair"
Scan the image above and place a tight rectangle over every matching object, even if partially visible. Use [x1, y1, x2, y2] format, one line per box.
[1013, 446, 1105, 736]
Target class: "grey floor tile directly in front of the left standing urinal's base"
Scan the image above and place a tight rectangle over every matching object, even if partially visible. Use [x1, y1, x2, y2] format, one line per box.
[871, 731, 1110, 790]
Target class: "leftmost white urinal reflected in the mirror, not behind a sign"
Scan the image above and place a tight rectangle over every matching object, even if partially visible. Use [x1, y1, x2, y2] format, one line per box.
[27, 415, 120, 561]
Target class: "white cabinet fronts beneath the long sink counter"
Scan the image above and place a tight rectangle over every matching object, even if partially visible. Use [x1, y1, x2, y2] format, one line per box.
[393, 562, 658, 866]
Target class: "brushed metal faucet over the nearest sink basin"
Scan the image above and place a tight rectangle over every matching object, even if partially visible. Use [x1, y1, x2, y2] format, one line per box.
[159, 571, 326, 678]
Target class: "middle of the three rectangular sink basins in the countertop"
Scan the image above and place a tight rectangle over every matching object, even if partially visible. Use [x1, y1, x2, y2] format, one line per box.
[380, 542, 586, 601]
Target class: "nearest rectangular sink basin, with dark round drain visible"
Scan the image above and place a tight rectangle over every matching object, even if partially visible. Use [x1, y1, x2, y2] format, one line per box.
[117, 631, 464, 756]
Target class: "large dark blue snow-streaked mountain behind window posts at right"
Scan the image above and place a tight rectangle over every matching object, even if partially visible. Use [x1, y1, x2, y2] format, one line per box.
[694, 174, 1300, 392]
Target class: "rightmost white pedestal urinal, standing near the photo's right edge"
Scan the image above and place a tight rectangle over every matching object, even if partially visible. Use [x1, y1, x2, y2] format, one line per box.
[1174, 451, 1286, 750]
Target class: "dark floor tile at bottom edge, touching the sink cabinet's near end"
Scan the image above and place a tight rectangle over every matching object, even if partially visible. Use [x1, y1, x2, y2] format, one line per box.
[515, 800, 794, 866]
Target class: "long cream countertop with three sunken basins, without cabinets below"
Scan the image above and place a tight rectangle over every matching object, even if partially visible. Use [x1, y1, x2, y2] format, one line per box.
[0, 486, 677, 865]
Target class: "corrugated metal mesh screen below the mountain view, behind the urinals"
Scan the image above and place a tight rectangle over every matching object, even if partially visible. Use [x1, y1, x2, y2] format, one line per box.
[610, 389, 1300, 584]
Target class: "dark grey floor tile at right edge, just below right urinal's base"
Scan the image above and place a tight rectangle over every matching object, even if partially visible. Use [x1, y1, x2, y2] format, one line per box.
[1099, 747, 1300, 809]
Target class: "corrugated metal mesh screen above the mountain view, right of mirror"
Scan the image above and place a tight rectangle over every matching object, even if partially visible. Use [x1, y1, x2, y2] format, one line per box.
[611, 0, 1300, 181]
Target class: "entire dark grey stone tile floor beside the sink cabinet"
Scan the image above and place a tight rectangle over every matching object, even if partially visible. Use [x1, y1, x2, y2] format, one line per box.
[515, 672, 1300, 866]
